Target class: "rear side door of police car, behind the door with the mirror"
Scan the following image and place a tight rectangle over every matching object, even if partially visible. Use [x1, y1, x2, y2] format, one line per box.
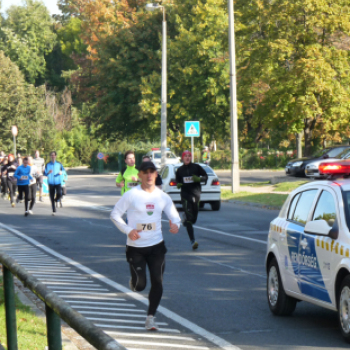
[279, 189, 319, 293]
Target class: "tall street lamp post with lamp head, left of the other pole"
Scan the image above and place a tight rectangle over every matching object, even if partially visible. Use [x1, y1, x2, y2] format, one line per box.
[146, 3, 167, 166]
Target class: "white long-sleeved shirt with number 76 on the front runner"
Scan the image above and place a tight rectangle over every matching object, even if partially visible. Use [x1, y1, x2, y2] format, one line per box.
[111, 185, 181, 247]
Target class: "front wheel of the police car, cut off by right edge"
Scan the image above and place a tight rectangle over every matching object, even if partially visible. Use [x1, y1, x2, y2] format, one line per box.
[338, 275, 350, 343]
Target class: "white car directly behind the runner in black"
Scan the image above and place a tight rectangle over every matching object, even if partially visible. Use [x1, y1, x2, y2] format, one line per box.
[159, 163, 221, 210]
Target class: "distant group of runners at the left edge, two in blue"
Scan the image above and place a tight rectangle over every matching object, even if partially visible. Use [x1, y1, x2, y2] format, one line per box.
[0, 150, 68, 216]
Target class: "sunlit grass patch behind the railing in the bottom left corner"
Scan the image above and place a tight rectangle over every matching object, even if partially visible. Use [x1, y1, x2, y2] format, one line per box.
[0, 277, 47, 350]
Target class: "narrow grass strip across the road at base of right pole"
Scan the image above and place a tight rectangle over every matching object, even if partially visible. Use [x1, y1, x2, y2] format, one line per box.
[221, 189, 288, 207]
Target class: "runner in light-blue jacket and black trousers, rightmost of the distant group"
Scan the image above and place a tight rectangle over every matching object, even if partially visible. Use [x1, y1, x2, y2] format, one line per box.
[44, 151, 64, 216]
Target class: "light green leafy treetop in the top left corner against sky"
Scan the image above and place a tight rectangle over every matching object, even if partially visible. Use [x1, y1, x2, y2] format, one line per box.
[0, 0, 56, 86]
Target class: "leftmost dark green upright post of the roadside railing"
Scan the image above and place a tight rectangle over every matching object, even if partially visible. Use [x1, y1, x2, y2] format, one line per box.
[2, 265, 18, 350]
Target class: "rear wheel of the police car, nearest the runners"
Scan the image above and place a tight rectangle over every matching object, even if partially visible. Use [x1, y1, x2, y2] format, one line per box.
[267, 258, 297, 316]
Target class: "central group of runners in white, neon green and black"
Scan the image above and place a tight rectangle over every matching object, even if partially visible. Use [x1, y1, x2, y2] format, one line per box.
[110, 151, 208, 330]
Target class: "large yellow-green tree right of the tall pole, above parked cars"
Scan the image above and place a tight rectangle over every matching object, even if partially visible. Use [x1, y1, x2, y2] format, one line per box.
[236, 0, 350, 155]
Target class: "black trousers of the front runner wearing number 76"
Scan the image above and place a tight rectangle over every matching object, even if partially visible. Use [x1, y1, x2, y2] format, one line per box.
[126, 241, 167, 316]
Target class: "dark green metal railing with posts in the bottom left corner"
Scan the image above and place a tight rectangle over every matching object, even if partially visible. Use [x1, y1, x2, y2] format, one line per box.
[0, 252, 126, 350]
